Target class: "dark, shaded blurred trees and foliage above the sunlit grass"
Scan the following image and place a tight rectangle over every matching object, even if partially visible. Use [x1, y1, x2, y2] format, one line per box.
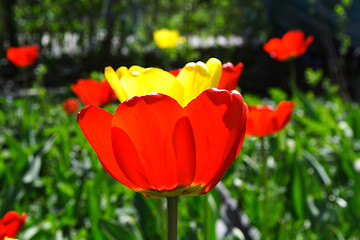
[0, 0, 360, 98]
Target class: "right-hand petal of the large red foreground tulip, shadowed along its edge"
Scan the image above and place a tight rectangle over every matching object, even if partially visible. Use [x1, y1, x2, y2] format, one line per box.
[185, 89, 247, 192]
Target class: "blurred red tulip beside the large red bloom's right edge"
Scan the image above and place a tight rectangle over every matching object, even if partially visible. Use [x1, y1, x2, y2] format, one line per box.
[246, 101, 294, 137]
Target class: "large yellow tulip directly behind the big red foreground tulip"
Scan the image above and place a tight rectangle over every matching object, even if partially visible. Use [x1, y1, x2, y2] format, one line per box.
[105, 58, 221, 107]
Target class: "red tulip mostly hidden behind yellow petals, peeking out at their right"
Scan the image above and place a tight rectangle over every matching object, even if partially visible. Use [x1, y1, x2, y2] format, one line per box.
[169, 62, 244, 91]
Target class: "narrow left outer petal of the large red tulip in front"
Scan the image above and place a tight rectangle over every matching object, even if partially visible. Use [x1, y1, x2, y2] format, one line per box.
[78, 105, 137, 189]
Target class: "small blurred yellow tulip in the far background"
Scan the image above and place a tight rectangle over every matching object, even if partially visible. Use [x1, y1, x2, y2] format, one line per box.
[153, 28, 186, 48]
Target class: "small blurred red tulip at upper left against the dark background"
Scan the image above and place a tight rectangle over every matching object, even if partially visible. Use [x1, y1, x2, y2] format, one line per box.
[6, 45, 40, 67]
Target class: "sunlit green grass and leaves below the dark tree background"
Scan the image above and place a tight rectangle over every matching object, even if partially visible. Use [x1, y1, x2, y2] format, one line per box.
[0, 86, 360, 240]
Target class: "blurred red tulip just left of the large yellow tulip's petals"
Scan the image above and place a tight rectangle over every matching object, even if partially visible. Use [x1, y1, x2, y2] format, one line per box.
[71, 79, 116, 106]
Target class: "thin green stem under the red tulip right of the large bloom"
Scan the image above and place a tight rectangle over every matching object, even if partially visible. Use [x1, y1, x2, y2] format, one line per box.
[260, 137, 268, 239]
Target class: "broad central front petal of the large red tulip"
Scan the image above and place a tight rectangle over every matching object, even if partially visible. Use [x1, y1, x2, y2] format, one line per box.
[112, 93, 195, 191]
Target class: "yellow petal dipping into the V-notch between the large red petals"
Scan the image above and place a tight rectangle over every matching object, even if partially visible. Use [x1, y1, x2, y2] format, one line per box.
[177, 62, 212, 105]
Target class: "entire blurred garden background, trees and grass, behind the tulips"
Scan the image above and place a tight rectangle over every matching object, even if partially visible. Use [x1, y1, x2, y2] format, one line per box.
[0, 0, 360, 240]
